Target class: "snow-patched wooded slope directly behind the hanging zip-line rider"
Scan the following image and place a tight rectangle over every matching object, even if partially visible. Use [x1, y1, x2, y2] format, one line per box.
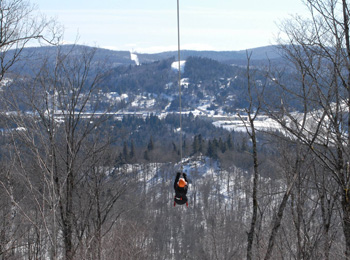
[117, 156, 283, 213]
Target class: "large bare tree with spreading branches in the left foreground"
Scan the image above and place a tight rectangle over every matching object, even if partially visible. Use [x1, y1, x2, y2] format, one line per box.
[3, 47, 133, 259]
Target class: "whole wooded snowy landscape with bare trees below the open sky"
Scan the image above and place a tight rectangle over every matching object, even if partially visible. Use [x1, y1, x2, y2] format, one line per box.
[0, 0, 350, 260]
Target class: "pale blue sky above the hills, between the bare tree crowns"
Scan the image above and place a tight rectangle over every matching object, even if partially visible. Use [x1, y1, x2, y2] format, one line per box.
[31, 0, 306, 52]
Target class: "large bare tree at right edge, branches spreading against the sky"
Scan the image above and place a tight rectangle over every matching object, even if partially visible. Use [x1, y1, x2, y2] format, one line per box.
[270, 0, 350, 259]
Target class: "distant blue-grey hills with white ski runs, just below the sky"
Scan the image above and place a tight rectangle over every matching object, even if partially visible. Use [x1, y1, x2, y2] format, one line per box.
[2, 45, 296, 114]
